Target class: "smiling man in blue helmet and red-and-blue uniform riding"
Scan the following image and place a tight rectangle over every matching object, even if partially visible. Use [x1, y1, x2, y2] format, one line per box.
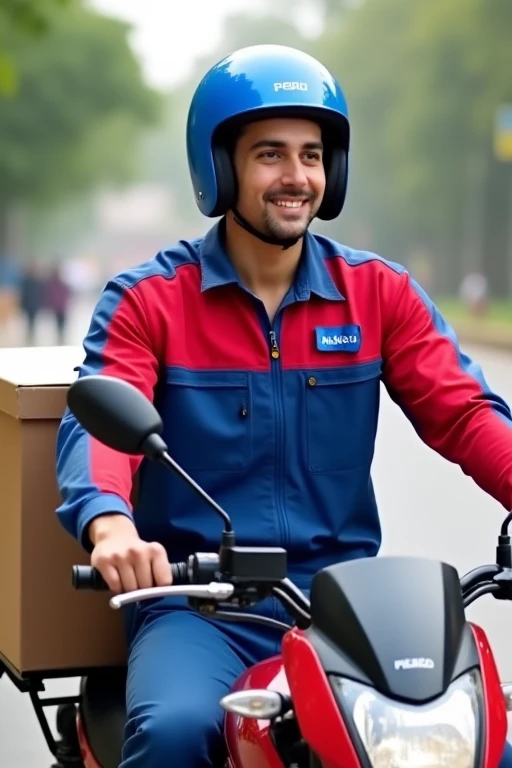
[58, 46, 512, 768]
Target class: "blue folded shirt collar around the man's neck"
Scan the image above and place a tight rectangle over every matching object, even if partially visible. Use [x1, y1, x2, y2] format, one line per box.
[199, 220, 345, 301]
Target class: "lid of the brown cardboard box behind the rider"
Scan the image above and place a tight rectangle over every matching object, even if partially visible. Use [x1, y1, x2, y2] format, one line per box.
[0, 346, 84, 419]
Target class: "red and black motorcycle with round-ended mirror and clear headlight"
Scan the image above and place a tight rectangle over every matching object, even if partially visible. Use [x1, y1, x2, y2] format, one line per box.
[13, 375, 512, 768]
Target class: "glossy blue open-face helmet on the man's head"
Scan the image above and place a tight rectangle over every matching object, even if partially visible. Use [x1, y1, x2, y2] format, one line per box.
[187, 45, 350, 220]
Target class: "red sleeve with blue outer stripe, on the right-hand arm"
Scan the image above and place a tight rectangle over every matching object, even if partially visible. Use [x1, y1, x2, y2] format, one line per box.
[383, 273, 512, 510]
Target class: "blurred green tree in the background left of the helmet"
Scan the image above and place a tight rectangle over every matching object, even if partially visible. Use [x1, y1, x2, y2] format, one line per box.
[0, 2, 159, 252]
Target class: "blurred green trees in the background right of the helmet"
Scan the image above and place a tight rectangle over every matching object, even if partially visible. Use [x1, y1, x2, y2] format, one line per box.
[314, 0, 512, 290]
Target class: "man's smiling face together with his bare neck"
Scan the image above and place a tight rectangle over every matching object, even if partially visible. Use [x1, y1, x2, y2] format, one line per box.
[226, 117, 325, 321]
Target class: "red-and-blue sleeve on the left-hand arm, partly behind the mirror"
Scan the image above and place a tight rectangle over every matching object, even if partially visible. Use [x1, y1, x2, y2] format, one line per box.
[57, 279, 159, 547]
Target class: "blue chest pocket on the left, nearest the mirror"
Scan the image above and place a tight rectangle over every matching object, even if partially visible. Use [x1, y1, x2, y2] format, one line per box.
[162, 369, 252, 472]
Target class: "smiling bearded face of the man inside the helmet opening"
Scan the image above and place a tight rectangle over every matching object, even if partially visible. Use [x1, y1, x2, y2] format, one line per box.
[234, 118, 325, 239]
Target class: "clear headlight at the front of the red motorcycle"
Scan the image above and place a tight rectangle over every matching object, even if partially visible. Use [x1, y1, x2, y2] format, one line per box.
[331, 670, 481, 768]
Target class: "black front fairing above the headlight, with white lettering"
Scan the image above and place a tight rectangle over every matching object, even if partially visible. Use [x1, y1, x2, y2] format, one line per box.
[306, 557, 479, 703]
